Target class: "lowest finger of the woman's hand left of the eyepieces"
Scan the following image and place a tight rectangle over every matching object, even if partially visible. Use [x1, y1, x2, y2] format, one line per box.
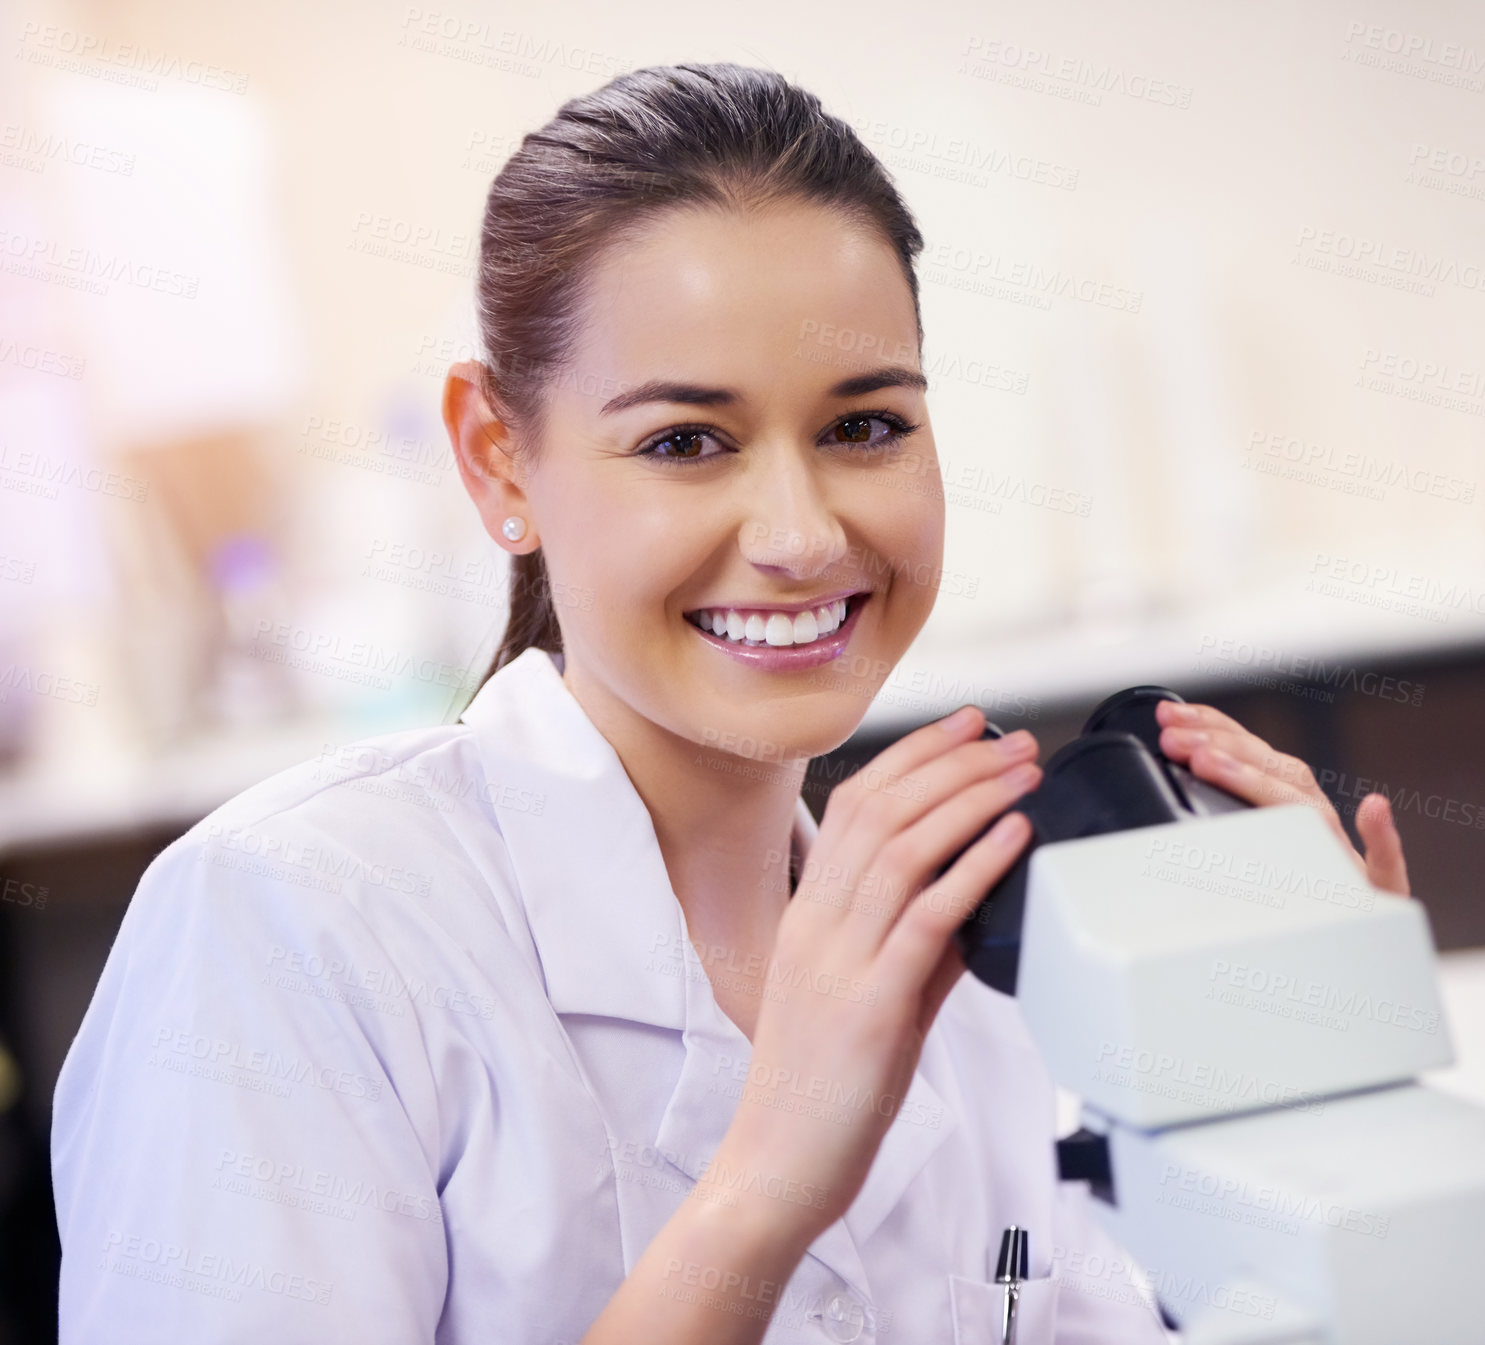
[876, 812, 1032, 993]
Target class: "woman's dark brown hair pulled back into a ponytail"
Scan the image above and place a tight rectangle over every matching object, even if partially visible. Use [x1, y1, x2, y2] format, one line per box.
[463, 62, 924, 706]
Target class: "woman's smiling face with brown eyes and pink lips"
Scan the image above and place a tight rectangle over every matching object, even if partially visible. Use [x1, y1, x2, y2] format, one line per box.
[524, 205, 944, 762]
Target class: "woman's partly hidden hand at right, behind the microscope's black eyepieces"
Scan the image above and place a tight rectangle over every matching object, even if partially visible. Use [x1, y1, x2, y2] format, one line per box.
[1155, 701, 1409, 897]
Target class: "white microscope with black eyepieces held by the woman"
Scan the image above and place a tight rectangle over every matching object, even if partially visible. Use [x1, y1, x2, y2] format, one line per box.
[944, 686, 1485, 1345]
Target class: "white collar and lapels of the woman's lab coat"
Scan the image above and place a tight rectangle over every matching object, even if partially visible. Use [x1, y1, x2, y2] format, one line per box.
[460, 649, 959, 1276]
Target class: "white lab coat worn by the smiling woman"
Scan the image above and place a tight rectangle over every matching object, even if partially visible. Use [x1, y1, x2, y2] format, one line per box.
[52, 650, 1166, 1345]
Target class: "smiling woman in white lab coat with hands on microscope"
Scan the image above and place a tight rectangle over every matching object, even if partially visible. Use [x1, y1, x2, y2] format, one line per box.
[53, 64, 1405, 1345]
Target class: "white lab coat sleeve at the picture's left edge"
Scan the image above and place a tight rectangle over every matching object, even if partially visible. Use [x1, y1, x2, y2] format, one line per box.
[52, 818, 448, 1345]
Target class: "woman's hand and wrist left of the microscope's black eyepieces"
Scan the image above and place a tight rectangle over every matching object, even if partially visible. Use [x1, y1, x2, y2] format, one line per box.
[698, 705, 1041, 1241]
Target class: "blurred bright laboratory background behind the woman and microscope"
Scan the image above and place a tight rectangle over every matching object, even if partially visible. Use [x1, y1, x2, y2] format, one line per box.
[0, 0, 1485, 1342]
